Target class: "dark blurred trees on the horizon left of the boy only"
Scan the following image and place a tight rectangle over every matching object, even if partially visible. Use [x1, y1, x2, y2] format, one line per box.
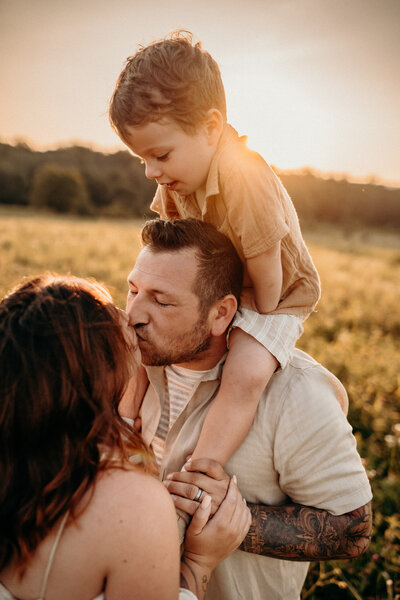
[0, 143, 155, 217]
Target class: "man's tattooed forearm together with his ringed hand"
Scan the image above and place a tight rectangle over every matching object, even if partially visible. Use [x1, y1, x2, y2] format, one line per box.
[164, 459, 372, 561]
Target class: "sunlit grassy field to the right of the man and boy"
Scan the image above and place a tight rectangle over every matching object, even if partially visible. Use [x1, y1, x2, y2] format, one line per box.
[299, 228, 400, 600]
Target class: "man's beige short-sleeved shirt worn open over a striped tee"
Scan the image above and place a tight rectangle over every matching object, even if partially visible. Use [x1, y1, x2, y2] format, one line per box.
[141, 349, 371, 600]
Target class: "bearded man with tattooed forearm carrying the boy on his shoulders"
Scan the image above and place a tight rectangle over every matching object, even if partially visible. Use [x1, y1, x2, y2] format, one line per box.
[127, 220, 371, 600]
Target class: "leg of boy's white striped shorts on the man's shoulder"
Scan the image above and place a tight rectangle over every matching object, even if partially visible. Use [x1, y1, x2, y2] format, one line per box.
[232, 308, 303, 369]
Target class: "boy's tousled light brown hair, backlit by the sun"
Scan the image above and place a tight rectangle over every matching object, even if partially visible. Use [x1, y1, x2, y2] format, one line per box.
[109, 31, 226, 141]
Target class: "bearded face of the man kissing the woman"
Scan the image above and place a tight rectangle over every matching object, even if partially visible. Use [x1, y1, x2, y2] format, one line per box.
[126, 247, 211, 369]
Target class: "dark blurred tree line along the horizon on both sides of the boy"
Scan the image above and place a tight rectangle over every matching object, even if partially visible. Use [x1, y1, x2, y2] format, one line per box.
[0, 143, 400, 228]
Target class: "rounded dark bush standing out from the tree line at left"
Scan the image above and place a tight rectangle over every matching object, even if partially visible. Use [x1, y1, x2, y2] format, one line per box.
[31, 163, 93, 215]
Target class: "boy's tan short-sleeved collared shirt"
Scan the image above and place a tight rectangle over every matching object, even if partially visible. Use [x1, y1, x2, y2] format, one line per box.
[150, 125, 320, 319]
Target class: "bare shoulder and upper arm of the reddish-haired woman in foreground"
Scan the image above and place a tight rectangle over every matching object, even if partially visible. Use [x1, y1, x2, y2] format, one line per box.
[82, 469, 179, 598]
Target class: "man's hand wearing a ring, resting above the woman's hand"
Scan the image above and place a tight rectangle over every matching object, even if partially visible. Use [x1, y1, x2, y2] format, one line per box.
[163, 458, 230, 515]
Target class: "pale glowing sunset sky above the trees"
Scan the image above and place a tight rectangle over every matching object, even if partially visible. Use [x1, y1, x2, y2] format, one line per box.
[0, 0, 400, 185]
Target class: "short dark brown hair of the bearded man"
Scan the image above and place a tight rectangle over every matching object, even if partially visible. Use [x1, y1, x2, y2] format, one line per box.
[142, 219, 243, 314]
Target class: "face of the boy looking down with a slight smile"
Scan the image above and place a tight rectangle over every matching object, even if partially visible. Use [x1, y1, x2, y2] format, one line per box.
[127, 119, 218, 196]
